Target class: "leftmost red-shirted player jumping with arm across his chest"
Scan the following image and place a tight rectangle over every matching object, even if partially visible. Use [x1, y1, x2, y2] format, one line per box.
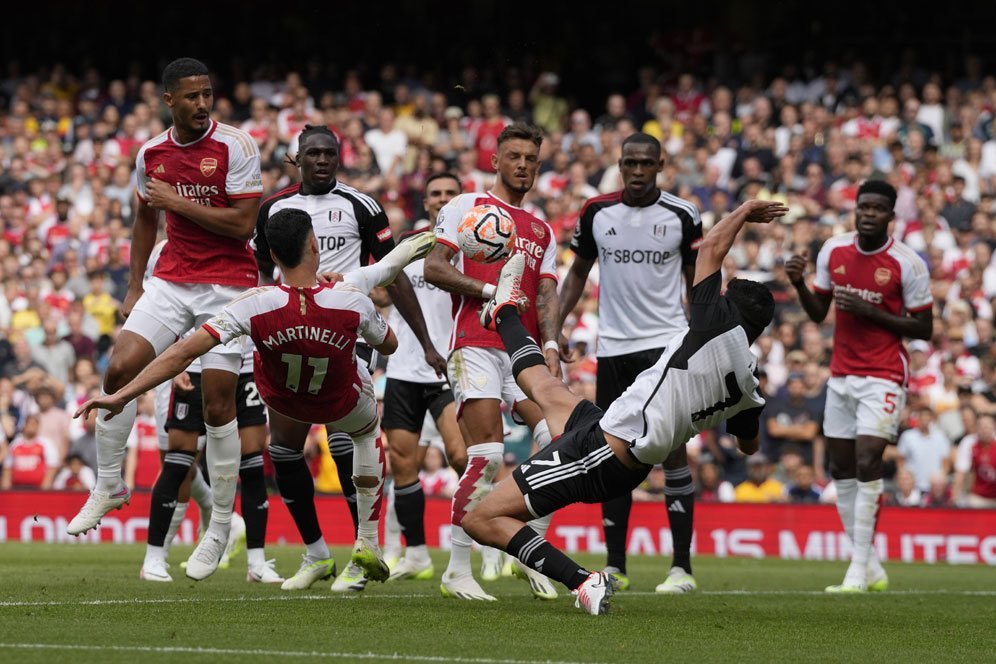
[67, 58, 262, 579]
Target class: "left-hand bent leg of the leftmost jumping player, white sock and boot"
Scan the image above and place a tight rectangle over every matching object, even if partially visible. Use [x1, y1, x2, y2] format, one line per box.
[66, 330, 156, 535]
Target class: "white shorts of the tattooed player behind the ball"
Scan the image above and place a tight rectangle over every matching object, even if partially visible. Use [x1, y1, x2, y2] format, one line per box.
[446, 347, 528, 415]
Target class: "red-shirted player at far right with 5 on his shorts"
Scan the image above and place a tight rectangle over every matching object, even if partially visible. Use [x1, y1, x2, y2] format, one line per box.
[785, 180, 933, 592]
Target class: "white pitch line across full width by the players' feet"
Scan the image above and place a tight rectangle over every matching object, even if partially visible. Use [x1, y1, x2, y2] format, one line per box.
[0, 590, 996, 608]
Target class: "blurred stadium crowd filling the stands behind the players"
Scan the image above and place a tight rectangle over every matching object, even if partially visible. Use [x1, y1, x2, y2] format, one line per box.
[0, 58, 996, 507]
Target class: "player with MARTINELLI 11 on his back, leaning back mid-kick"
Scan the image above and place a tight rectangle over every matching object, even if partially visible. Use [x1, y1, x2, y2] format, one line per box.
[76, 209, 435, 581]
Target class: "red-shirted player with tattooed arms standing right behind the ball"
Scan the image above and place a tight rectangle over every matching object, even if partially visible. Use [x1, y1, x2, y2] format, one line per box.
[425, 123, 560, 601]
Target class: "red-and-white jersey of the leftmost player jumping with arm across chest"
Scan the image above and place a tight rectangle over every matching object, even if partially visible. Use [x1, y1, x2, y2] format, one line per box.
[135, 121, 263, 288]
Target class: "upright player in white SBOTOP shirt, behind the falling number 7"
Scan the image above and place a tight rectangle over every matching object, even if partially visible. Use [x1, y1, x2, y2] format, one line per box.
[560, 133, 702, 593]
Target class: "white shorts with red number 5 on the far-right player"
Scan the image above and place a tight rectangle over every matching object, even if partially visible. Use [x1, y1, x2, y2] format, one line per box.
[823, 376, 906, 441]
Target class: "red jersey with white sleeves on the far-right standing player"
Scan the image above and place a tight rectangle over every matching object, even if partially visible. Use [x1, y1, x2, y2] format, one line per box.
[813, 232, 933, 385]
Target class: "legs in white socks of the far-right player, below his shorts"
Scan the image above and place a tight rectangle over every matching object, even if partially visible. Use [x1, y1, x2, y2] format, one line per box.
[826, 435, 889, 592]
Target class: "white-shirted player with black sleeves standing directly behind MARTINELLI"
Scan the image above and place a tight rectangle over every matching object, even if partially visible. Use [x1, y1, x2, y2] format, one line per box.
[255, 125, 446, 592]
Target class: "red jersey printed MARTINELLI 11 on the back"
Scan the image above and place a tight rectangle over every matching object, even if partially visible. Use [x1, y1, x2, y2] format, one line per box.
[204, 283, 389, 424]
